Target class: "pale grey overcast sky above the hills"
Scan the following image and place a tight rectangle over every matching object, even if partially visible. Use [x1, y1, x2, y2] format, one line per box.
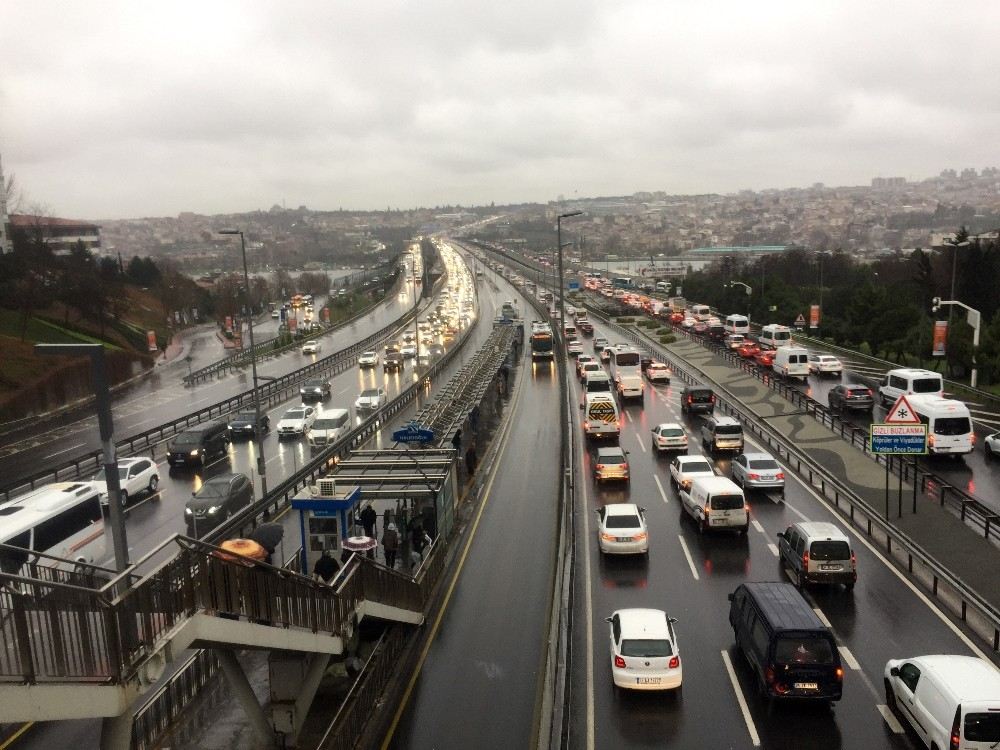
[0, 0, 1000, 219]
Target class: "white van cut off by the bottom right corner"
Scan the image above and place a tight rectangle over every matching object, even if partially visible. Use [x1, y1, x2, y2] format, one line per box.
[883, 654, 1000, 750]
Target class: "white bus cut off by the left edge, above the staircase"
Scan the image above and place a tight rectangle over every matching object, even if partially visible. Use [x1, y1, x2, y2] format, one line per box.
[0, 482, 105, 574]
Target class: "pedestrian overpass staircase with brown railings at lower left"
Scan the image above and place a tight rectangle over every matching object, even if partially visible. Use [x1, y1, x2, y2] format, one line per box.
[0, 535, 425, 747]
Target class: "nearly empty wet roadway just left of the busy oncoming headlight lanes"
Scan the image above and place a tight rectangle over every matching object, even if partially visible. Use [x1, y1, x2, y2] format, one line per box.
[0, 268, 413, 490]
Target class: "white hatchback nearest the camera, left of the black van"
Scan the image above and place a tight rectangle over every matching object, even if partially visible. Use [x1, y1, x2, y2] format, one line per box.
[607, 609, 683, 690]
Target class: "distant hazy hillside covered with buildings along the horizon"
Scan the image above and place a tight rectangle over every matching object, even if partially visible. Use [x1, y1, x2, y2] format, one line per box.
[0, 154, 1000, 270]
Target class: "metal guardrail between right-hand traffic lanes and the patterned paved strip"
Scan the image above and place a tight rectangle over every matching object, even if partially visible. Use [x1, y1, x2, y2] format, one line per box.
[594, 311, 1000, 652]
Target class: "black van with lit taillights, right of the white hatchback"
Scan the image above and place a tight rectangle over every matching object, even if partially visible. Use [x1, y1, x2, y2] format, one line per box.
[729, 583, 844, 701]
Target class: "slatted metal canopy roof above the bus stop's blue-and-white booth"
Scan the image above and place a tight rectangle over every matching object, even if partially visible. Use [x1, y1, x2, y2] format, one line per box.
[327, 448, 455, 499]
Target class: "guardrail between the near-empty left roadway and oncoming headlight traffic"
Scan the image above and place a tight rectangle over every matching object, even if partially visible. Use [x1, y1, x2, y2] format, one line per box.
[0, 276, 445, 502]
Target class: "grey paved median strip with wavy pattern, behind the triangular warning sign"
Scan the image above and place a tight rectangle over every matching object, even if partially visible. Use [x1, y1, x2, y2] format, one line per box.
[664, 339, 1000, 620]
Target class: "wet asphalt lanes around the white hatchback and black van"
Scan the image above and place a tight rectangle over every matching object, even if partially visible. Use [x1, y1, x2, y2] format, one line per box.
[569, 316, 981, 750]
